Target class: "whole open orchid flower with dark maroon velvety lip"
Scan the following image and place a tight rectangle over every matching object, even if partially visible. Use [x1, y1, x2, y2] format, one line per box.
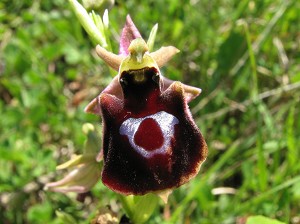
[85, 17, 207, 195]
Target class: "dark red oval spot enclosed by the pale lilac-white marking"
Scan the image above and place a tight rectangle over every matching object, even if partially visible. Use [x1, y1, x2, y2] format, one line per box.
[134, 118, 164, 151]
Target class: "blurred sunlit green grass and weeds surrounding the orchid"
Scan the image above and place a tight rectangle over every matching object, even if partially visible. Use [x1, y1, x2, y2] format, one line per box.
[0, 0, 300, 224]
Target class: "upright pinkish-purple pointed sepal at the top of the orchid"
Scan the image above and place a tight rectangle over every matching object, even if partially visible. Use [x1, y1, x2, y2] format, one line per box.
[119, 15, 142, 56]
